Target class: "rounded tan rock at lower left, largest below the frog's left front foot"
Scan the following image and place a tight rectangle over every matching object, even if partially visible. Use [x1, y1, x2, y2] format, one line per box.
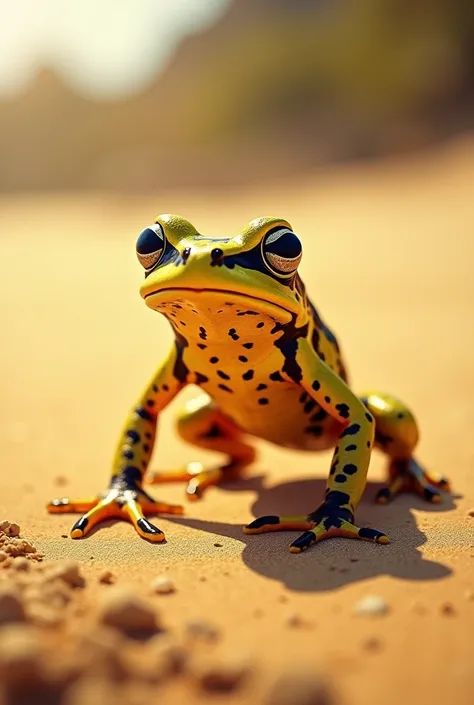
[100, 588, 159, 636]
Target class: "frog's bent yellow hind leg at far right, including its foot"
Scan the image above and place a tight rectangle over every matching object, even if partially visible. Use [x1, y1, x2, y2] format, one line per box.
[361, 393, 450, 504]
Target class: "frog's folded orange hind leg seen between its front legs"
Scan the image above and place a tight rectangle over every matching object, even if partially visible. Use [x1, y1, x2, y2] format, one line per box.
[147, 394, 256, 500]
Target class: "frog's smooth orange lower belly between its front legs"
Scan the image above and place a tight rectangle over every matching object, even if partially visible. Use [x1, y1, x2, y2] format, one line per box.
[207, 382, 343, 450]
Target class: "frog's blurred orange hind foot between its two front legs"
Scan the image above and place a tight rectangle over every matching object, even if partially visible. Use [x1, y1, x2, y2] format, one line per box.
[147, 462, 244, 501]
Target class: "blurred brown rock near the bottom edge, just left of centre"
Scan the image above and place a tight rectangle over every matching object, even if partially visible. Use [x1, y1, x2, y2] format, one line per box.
[191, 656, 250, 692]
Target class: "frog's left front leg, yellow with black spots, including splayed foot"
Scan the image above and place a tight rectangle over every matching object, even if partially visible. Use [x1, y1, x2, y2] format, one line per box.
[48, 347, 184, 542]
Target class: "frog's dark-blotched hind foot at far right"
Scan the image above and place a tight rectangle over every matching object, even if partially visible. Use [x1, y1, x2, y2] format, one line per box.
[375, 458, 451, 504]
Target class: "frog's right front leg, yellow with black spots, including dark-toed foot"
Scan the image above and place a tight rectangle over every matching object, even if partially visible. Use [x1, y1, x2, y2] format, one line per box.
[244, 339, 389, 553]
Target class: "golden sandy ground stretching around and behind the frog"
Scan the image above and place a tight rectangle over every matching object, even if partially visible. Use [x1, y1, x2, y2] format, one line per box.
[0, 140, 474, 705]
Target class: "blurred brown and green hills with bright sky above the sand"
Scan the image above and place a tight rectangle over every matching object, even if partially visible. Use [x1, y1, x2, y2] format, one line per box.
[0, 0, 474, 193]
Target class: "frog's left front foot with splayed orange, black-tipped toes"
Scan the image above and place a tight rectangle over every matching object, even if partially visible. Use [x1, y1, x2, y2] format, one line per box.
[47, 478, 183, 543]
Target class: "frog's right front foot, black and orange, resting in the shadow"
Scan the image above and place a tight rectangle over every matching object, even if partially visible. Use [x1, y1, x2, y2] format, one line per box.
[244, 504, 390, 553]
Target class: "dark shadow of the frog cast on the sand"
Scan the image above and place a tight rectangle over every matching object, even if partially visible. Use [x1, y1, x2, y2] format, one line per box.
[166, 476, 455, 592]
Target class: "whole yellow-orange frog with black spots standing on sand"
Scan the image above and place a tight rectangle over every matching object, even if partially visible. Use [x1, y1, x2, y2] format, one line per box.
[47, 214, 450, 553]
